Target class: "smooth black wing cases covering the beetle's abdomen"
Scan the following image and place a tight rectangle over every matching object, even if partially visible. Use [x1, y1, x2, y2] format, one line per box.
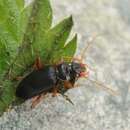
[16, 66, 56, 99]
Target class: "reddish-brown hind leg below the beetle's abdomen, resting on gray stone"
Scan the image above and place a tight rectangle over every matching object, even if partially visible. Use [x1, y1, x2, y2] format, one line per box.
[31, 93, 46, 109]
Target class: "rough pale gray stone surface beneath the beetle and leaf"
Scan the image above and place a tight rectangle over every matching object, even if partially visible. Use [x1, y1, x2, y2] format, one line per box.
[0, 0, 130, 130]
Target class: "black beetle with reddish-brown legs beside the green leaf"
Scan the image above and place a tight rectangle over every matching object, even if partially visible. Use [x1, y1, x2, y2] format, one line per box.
[16, 58, 86, 104]
